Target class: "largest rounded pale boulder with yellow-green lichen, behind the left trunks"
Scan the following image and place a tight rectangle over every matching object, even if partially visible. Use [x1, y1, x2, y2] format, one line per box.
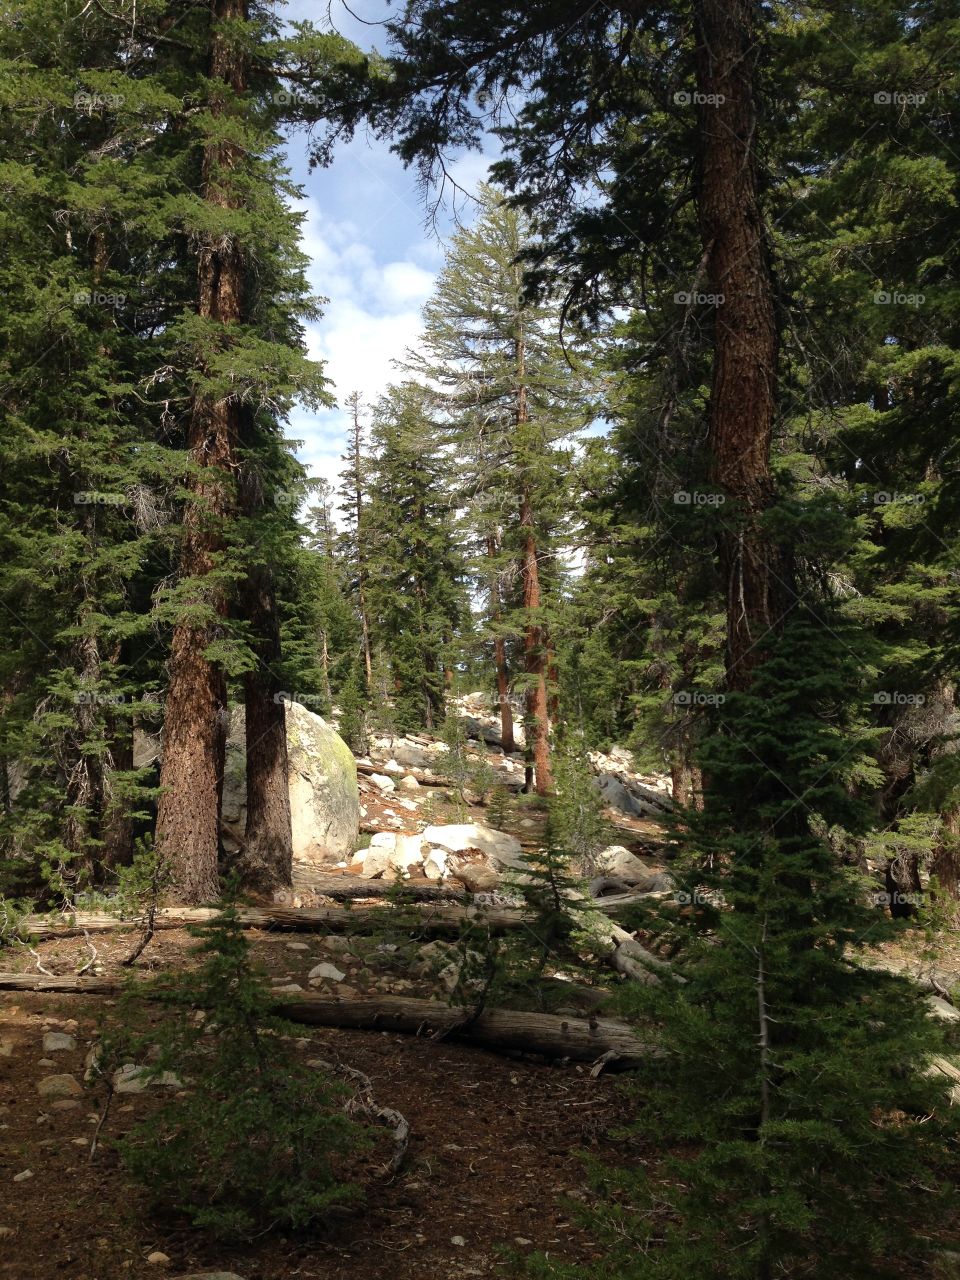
[223, 701, 360, 867]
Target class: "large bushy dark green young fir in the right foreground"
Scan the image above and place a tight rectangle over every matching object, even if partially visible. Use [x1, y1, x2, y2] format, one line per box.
[541, 608, 955, 1280]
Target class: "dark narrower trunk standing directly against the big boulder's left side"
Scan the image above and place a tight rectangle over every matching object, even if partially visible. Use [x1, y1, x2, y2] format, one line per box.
[237, 564, 293, 893]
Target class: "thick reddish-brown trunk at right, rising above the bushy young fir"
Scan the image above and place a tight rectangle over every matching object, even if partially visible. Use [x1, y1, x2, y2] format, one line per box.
[695, 0, 788, 689]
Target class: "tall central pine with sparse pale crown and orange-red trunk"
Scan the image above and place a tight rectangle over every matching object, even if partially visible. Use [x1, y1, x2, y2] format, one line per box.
[411, 187, 590, 794]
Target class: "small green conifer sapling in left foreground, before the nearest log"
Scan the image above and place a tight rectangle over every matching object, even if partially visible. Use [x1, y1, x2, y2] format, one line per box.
[105, 904, 364, 1239]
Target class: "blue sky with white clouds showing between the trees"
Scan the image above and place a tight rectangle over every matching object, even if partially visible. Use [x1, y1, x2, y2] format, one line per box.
[285, 0, 489, 479]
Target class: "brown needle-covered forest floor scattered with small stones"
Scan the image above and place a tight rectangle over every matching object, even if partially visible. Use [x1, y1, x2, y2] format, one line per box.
[0, 747, 960, 1280]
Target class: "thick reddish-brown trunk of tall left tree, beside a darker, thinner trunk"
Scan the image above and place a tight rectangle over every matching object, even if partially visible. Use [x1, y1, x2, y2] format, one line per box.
[156, 0, 247, 902]
